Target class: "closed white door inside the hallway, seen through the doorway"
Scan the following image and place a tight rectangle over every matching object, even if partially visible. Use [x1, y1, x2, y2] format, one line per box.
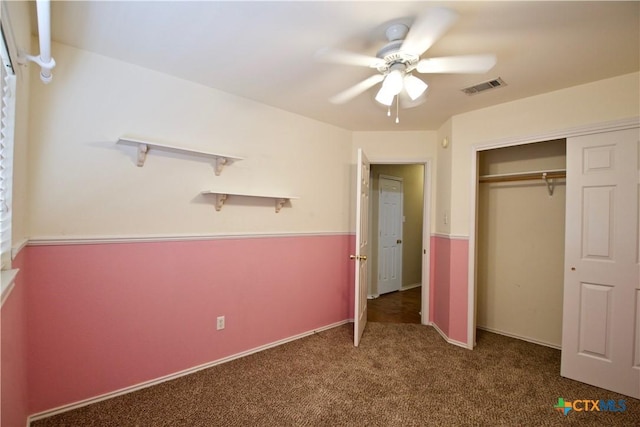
[378, 176, 402, 294]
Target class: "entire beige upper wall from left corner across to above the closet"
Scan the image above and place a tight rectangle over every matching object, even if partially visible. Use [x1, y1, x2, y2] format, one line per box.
[21, 33, 640, 238]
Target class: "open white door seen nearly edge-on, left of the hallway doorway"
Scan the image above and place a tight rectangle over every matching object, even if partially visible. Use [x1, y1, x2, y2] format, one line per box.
[351, 149, 371, 347]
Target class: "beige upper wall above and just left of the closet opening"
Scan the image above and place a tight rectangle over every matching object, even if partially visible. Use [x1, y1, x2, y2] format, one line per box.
[437, 73, 640, 235]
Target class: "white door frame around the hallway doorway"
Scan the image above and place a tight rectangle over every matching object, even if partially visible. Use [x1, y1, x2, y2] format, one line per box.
[369, 156, 433, 325]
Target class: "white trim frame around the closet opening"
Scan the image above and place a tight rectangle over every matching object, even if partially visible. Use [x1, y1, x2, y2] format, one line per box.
[466, 117, 640, 350]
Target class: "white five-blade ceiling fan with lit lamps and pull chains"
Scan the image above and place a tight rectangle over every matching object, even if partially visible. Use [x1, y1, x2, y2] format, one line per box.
[316, 7, 496, 123]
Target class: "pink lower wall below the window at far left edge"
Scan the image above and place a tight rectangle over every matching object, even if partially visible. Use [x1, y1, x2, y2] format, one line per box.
[0, 250, 29, 427]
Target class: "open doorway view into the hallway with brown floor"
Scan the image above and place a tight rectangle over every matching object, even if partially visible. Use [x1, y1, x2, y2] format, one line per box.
[367, 163, 429, 324]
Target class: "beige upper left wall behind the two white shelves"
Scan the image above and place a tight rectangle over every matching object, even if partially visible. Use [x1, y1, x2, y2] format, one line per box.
[29, 43, 351, 238]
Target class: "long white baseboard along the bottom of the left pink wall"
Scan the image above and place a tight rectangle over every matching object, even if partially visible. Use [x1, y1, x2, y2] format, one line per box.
[27, 319, 353, 426]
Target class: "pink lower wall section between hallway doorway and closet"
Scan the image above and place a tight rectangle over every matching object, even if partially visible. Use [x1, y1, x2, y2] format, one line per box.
[430, 236, 469, 343]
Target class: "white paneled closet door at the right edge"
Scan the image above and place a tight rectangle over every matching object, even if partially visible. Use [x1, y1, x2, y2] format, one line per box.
[561, 129, 640, 398]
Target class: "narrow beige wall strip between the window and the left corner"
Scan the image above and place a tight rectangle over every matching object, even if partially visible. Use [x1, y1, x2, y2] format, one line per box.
[2, 1, 31, 246]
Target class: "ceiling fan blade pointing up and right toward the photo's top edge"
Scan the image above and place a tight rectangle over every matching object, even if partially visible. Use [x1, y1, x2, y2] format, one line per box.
[401, 7, 458, 56]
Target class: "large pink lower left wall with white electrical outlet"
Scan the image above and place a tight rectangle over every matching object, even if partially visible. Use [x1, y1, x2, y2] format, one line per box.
[25, 235, 353, 416]
